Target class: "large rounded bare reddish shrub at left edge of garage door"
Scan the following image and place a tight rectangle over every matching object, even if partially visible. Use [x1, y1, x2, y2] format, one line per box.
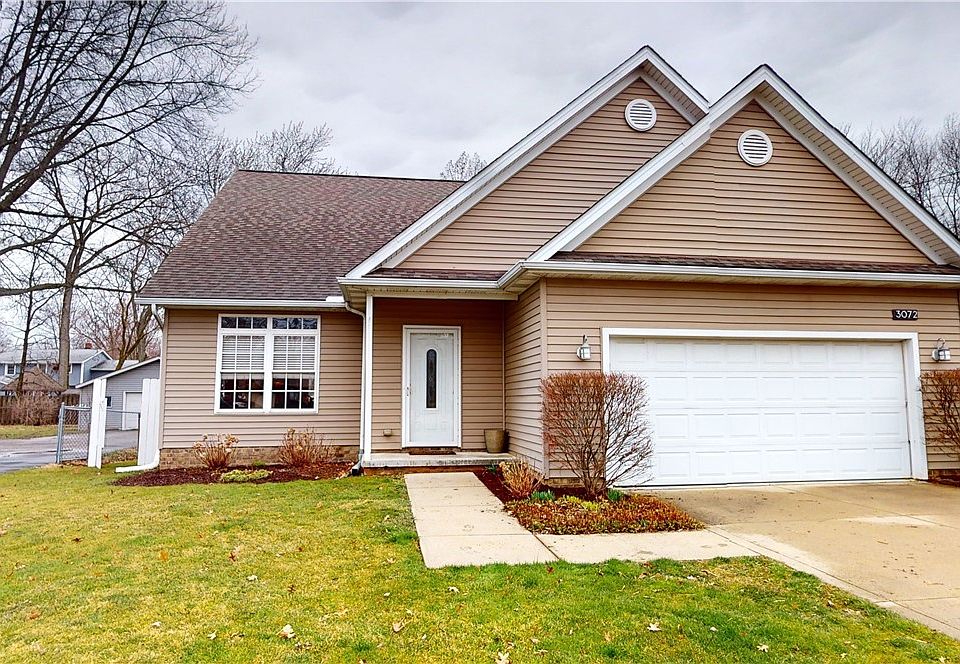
[540, 371, 653, 498]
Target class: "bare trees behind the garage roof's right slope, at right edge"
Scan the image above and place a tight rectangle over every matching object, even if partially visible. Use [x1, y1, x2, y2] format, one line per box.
[848, 115, 960, 235]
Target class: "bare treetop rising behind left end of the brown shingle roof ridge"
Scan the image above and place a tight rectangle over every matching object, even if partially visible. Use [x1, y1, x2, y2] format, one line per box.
[195, 122, 344, 200]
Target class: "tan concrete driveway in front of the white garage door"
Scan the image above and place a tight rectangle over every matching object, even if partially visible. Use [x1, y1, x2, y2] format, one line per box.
[657, 482, 960, 638]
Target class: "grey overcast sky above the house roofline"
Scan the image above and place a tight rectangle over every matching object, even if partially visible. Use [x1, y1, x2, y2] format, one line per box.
[222, 3, 960, 177]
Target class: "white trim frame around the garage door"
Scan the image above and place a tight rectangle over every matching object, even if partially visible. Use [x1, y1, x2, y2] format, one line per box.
[600, 327, 928, 480]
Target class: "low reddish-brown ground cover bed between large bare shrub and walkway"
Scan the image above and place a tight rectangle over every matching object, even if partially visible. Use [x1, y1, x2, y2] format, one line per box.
[505, 496, 703, 535]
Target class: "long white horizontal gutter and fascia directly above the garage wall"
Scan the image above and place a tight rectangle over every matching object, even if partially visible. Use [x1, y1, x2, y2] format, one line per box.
[523, 261, 960, 285]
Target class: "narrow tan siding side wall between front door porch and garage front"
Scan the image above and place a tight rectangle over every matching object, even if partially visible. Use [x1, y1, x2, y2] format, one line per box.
[504, 282, 544, 472]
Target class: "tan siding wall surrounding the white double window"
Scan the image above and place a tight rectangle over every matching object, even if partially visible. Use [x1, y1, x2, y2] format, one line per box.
[161, 309, 362, 448]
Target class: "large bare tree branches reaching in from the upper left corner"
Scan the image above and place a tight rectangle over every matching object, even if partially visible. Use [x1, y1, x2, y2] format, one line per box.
[0, 0, 252, 268]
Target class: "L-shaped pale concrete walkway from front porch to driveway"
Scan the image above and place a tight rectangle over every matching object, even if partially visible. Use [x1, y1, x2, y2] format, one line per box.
[406, 472, 756, 568]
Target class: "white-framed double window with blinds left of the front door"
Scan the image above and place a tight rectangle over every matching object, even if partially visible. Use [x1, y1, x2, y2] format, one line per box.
[217, 316, 320, 412]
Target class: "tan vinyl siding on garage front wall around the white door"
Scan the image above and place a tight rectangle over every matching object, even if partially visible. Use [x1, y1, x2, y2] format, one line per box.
[547, 279, 960, 468]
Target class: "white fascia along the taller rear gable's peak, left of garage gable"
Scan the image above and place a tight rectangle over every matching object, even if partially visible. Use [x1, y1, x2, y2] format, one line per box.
[346, 46, 709, 279]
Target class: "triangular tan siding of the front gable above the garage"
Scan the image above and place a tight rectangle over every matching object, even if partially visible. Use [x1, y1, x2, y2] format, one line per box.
[577, 102, 930, 263]
